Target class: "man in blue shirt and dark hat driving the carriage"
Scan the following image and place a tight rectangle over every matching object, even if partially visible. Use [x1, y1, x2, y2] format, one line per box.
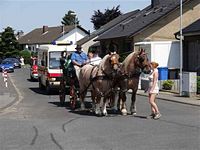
[71, 45, 88, 79]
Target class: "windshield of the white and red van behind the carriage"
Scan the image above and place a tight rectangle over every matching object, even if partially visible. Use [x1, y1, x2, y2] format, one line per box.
[49, 51, 61, 69]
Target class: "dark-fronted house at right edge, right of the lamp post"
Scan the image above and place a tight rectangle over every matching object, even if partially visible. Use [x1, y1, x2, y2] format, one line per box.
[180, 19, 200, 75]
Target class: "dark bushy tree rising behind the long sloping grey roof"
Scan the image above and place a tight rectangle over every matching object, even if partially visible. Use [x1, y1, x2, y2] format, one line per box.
[91, 5, 122, 30]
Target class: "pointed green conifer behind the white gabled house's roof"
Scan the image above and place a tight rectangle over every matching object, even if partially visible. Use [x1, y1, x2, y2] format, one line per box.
[61, 10, 79, 25]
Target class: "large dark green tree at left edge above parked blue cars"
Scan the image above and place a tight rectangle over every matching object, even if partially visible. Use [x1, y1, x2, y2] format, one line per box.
[0, 27, 19, 53]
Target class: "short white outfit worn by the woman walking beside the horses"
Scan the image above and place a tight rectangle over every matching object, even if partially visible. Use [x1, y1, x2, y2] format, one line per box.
[148, 69, 159, 94]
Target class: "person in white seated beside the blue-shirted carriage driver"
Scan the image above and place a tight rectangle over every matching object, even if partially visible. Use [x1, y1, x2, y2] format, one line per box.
[88, 49, 102, 66]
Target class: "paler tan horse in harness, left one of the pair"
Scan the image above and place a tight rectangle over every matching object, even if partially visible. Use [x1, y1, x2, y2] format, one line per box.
[79, 53, 119, 115]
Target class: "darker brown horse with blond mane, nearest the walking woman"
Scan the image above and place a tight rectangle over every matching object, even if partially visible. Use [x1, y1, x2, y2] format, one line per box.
[117, 49, 151, 115]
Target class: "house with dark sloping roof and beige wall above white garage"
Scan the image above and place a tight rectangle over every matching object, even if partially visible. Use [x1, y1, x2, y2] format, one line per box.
[96, 0, 200, 51]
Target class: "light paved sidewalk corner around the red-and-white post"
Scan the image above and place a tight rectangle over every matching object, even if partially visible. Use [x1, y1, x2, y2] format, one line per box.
[0, 73, 18, 112]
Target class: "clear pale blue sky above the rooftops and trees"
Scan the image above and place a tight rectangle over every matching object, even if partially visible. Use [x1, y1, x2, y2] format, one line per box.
[0, 0, 151, 34]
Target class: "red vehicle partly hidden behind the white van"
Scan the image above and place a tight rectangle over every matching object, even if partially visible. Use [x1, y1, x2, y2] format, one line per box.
[30, 57, 38, 80]
